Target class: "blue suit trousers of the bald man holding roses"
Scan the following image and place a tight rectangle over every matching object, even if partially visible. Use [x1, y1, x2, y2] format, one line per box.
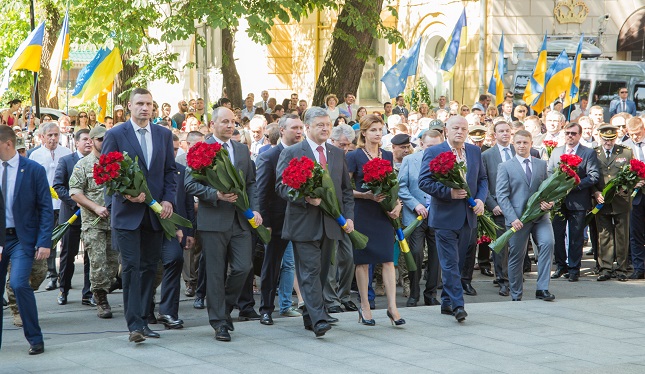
[435, 222, 473, 309]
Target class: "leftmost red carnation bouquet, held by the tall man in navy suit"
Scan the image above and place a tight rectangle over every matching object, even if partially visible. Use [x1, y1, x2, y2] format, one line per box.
[93, 152, 193, 239]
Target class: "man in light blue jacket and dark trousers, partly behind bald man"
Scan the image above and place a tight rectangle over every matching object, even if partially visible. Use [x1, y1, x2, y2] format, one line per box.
[399, 130, 443, 307]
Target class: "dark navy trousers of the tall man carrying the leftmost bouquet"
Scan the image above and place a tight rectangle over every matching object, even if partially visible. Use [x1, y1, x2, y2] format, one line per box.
[112, 211, 164, 331]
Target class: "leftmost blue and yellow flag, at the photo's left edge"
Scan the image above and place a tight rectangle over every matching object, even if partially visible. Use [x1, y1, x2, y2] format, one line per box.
[0, 21, 45, 93]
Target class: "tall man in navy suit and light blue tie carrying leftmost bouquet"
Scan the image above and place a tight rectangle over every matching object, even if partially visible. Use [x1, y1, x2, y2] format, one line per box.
[101, 88, 177, 343]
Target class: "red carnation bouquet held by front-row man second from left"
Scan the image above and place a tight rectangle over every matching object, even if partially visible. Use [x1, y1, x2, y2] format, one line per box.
[186, 142, 271, 244]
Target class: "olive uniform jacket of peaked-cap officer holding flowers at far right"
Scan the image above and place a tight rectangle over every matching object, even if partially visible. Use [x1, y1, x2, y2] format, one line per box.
[592, 144, 632, 214]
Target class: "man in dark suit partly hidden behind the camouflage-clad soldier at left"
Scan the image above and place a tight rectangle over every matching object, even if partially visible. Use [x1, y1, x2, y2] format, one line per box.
[54, 129, 92, 305]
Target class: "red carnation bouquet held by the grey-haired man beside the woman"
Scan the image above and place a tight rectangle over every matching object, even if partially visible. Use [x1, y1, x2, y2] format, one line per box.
[282, 156, 368, 251]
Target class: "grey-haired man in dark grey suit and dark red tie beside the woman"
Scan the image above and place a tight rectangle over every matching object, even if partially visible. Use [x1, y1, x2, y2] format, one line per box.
[275, 107, 354, 337]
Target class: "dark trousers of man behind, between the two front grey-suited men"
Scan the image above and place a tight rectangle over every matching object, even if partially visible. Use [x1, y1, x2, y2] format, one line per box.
[260, 235, 293, 314]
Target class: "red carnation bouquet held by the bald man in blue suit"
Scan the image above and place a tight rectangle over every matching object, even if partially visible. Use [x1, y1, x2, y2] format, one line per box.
[430, 151, 500, 245]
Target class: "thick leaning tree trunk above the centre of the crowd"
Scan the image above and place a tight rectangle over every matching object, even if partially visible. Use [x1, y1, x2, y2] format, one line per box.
[312, 0, 383, 105]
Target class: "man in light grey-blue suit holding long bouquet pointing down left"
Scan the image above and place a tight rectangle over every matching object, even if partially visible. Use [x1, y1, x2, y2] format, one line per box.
[496, 130, 555, 301]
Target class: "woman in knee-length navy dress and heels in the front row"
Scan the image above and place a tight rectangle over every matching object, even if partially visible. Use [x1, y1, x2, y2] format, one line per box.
[347, 114, 405, 326]
